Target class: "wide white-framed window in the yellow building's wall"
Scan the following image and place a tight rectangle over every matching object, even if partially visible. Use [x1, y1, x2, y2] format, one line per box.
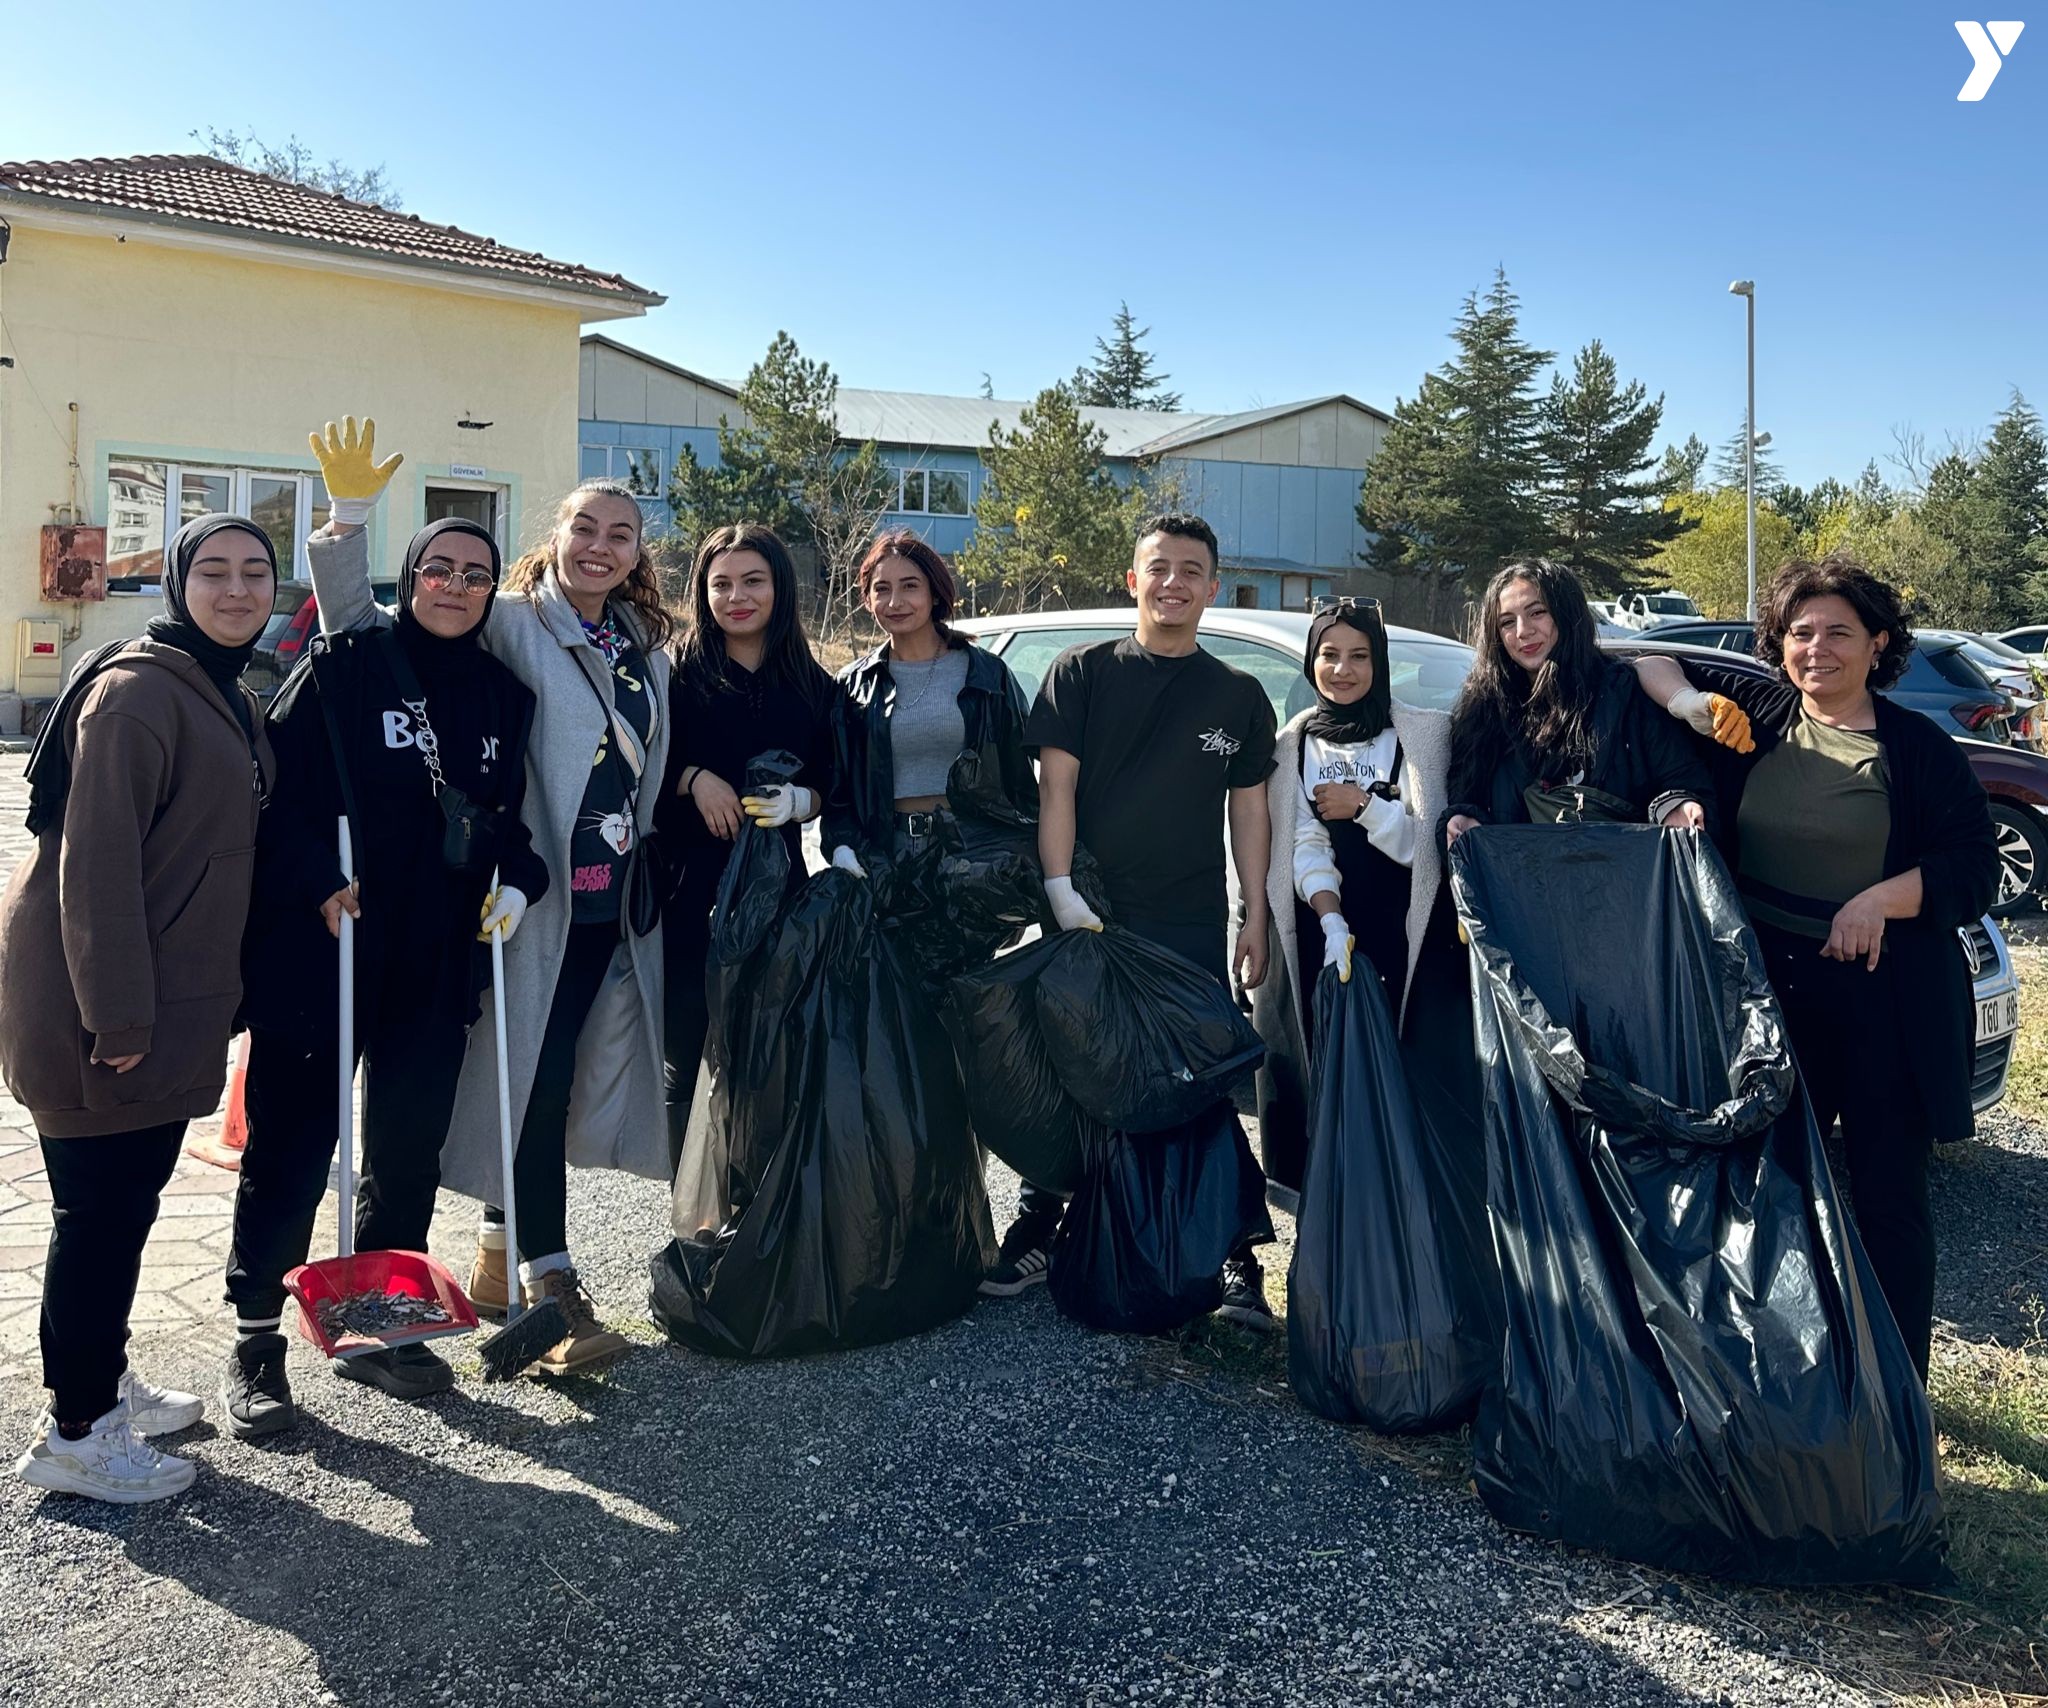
[106, 457, 328, 594]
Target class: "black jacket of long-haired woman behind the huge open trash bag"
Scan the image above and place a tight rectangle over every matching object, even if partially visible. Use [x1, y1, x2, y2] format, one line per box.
[1438, 659, 1716, 834]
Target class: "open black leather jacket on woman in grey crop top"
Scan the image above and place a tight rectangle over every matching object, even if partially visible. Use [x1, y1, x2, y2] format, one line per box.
[821, 635, 1038, 856]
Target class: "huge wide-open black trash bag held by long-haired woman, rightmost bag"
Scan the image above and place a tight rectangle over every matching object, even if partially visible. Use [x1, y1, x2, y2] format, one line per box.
[1452, 825, 1942, 1583]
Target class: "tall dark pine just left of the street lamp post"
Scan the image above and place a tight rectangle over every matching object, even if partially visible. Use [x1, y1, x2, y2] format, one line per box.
[1536, 338, 1686, 594]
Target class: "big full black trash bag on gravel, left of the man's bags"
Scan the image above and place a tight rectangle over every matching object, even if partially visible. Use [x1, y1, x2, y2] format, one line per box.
[651, 868, 995, 1358]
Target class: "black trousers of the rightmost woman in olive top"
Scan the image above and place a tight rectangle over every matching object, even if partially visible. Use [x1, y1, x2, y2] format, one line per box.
[1757, 926, 1935, 1382]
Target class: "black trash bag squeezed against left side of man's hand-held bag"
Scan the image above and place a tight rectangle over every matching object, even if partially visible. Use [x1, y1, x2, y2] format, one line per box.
[946, 936, 1094, 1192]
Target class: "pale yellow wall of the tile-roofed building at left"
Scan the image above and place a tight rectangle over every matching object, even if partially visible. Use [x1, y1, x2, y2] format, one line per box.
[0, 223, 582, 690]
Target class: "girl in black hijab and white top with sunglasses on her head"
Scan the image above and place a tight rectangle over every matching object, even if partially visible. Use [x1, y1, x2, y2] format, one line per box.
[1251, 598, 1470, 1204]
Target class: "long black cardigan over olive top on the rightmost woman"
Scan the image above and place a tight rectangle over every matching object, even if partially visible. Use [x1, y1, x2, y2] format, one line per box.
[1669, 657, 1999, 1139]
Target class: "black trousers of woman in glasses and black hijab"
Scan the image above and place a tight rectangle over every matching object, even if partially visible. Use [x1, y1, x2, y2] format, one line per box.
[227, 1003, 469, 1321]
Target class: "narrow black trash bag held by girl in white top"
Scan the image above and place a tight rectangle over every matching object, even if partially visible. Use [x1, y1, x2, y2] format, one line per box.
[1286, 965, 1501, 1434]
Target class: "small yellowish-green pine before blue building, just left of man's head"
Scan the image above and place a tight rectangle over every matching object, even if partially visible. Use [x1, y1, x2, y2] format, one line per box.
[961, 385, 1163, 610]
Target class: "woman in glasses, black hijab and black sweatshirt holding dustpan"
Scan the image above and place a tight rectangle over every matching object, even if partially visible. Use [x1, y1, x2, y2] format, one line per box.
[221, 520, 547, 1438]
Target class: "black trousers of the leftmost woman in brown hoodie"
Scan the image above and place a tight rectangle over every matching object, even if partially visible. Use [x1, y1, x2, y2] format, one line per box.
[41, 1120, 184, 1423]
